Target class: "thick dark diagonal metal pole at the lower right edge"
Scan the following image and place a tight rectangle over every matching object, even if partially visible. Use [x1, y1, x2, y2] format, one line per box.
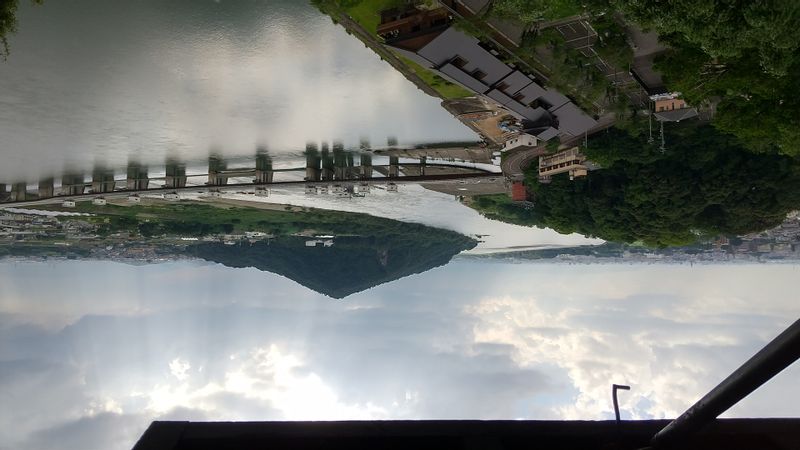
[650, 320, 800, 448]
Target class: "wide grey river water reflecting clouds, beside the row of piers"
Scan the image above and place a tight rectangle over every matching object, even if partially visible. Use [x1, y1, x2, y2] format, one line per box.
[0, 0, 477, 182]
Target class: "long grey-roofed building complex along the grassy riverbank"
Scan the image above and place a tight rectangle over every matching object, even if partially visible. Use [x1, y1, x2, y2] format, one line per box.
[378, 6, 597, 140]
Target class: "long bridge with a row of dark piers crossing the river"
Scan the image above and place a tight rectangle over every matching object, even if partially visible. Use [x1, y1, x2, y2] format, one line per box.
[0, 151, 501, 206]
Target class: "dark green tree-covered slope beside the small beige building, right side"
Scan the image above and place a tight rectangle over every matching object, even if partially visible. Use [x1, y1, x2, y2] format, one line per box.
[476, 124, 800, 247]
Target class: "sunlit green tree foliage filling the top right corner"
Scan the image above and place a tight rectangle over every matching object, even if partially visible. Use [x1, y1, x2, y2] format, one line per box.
[614, 0, 800, 156]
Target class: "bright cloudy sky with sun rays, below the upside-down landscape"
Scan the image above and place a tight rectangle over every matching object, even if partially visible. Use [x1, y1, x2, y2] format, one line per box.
[0, 258, 800, 449]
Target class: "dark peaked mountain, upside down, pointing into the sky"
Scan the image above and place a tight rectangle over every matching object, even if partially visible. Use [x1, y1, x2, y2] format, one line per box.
[187, 229, 477, 298]
